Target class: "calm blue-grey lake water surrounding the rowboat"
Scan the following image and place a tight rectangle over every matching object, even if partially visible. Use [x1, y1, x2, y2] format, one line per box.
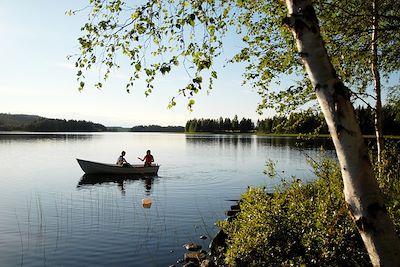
[0, 133, 332, 266]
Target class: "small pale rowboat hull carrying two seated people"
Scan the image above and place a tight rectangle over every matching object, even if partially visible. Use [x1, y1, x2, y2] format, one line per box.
[76, 159, 160, 175]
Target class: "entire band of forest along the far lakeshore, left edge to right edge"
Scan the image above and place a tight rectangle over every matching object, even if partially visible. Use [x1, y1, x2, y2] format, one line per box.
[0, 106, 400, 138]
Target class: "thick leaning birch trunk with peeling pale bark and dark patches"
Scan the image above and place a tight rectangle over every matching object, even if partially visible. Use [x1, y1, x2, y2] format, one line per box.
[284, 0, 400, 266]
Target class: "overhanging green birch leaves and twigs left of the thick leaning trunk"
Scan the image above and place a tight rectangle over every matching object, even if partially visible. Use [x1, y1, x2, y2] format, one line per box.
[67, 0, 315, 112]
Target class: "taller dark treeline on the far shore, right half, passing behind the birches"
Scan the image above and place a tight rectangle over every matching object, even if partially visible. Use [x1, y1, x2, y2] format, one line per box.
[185, 106, 400, 135]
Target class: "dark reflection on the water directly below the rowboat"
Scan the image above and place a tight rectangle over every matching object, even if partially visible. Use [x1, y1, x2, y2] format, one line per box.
[76, 174, 156, 196]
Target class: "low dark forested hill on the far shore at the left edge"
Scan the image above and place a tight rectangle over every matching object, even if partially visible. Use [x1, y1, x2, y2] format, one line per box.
[0, 114, 107, 132]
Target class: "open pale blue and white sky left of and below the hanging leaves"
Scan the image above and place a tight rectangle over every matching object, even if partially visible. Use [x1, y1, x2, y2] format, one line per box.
[0, 0, 280, 127]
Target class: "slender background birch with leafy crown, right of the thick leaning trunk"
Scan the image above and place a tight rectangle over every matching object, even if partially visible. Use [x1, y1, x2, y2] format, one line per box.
[316, 0, 400, 170]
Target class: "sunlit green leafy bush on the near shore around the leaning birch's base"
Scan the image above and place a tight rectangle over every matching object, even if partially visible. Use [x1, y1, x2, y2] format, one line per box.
[218, 141, 400, 266]
